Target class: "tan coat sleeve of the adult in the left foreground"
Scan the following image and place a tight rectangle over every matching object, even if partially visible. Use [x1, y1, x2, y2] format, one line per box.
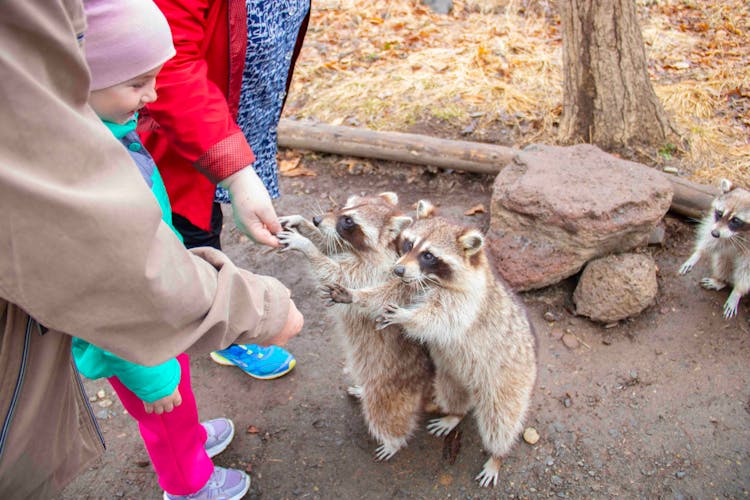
[0, 0, 289, 364]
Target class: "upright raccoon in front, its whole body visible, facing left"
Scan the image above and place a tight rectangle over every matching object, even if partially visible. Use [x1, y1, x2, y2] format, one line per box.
[327, 202, 537, 486]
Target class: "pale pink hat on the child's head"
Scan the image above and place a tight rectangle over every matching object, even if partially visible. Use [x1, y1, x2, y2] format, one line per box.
[83, 0, 175, 90]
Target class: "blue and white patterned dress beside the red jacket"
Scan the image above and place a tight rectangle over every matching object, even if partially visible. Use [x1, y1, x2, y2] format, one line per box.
[216, 0, 310, 203]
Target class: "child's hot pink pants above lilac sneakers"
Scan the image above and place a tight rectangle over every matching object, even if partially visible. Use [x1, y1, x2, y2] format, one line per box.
[108, 354, 214, 495]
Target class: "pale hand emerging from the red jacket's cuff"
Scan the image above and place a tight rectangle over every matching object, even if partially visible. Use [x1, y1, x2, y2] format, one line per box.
[219, 166, 281, 247]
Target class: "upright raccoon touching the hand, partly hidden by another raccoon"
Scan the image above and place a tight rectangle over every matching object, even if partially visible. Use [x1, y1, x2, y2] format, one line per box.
[277, 193, 434, 460]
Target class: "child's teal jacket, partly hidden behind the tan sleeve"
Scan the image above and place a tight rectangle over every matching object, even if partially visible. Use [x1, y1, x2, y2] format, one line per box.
[73, 115, 182, 403]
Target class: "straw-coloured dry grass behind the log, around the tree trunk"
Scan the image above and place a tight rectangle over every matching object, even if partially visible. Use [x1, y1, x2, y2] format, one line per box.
[285, 0, 750, 187]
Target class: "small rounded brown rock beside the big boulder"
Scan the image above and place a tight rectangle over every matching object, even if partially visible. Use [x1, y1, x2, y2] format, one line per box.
[573, 253, 659, 323]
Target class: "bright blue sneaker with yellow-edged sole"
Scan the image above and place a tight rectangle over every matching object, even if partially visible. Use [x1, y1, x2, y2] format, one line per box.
[211, 344, 297, 380]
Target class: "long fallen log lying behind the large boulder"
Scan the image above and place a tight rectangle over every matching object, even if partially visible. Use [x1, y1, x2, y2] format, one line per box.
[278, 119, 718, 218]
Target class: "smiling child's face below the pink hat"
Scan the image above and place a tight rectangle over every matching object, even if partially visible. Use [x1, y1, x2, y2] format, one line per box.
[89, 66, 161, 124]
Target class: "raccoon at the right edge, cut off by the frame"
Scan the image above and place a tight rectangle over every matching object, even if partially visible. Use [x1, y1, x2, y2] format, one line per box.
[680, 179, 750, 318]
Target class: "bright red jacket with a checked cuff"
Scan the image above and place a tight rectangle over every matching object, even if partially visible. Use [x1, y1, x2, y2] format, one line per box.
[138, 0, 309, 230]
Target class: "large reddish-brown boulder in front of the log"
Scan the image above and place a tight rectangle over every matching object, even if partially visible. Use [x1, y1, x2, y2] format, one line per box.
[488, 144, 672, 290]
